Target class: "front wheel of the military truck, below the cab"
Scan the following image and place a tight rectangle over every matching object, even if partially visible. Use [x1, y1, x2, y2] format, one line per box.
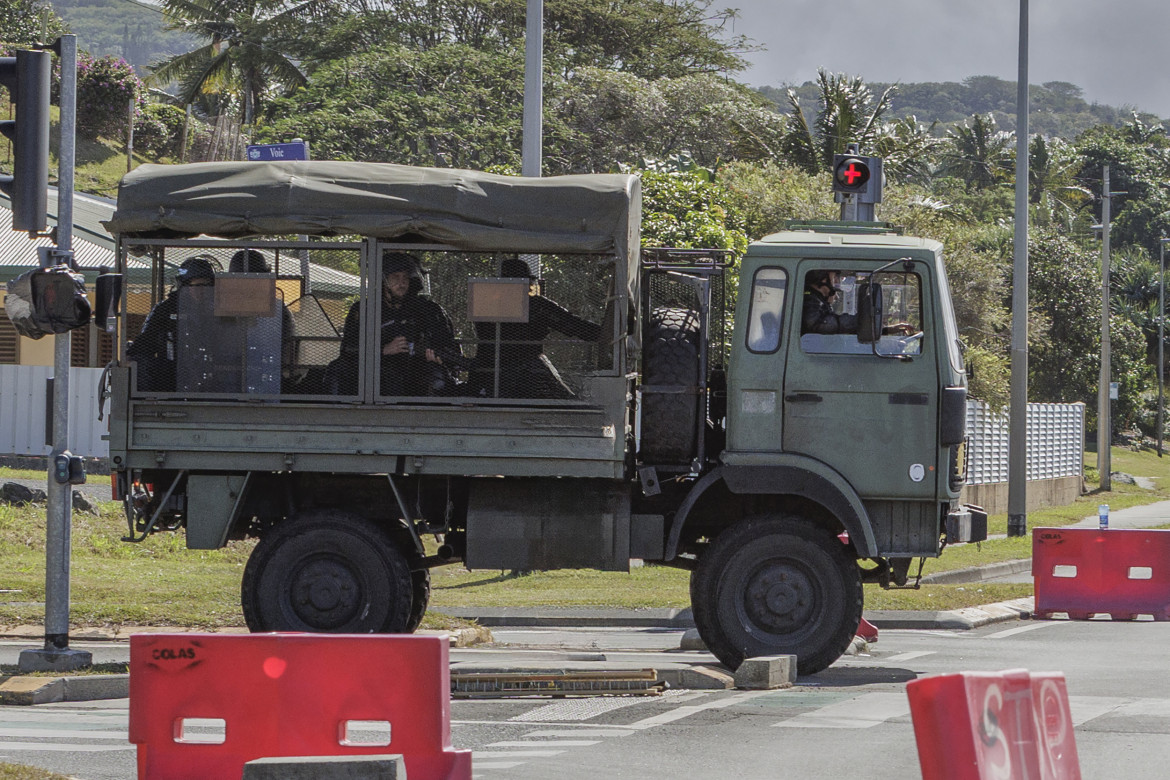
[691, 516, 865, 675]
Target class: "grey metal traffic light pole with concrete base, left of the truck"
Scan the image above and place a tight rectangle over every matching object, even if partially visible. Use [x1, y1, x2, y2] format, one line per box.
[20, 35, 94, 671]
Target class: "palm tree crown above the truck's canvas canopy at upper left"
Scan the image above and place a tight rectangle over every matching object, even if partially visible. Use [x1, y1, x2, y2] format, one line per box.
[151, 0, 329, 125]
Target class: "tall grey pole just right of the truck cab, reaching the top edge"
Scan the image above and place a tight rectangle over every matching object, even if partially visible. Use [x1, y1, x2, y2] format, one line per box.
[1007, 0, 1028, 537]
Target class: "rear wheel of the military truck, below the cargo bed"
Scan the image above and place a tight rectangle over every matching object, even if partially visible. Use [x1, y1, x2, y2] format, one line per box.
[241, 511, 413, 634]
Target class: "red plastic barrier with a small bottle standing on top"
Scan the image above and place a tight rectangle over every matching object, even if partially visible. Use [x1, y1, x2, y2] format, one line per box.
[1032, 529, 1170, 620]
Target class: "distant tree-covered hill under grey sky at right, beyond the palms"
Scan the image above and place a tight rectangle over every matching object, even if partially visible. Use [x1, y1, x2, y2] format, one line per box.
[759, 76, 1156, 138]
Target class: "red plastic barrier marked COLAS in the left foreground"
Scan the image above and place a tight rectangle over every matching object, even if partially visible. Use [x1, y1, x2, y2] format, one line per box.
[130, 634, 472, 780]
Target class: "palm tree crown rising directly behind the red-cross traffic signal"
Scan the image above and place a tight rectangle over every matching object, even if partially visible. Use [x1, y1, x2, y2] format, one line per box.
[784, 69, 896, 173]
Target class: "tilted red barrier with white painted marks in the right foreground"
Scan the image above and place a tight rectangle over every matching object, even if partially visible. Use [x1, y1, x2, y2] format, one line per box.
[906, 669, 1081, 780]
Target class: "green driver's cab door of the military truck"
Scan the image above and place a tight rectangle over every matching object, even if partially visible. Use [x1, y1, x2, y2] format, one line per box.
[783, 261, 941, 499]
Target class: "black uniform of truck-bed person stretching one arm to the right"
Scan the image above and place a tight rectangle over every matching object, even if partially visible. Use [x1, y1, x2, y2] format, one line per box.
[472, 295, 601, 399]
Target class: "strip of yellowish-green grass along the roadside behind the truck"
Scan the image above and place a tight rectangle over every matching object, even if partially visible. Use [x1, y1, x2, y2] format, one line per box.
[0, 448, 1170, 633]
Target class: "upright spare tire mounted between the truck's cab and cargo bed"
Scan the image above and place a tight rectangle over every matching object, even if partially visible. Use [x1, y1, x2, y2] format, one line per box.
[641, 308, 700, 464]
